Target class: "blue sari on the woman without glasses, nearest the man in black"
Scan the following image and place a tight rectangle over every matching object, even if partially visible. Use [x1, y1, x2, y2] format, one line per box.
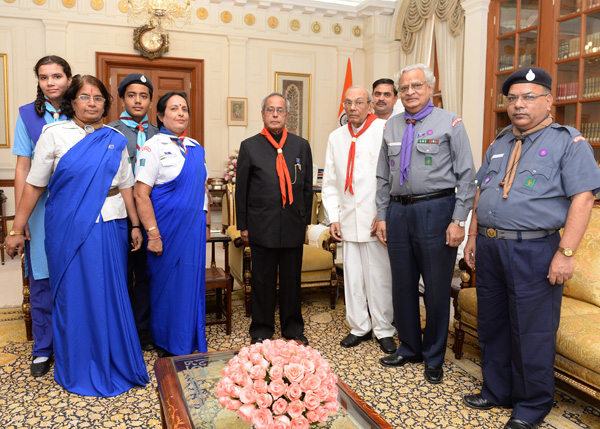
[147, 140, 206, 355]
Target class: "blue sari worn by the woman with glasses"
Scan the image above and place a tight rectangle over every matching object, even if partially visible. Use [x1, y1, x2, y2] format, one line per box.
[46, 127, 148, 397]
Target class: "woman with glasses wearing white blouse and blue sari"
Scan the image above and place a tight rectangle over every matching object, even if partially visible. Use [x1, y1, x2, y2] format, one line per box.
[7, 76, 148, 397]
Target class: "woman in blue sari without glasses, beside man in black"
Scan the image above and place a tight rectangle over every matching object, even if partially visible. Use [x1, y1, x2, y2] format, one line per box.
[134, 92, 208, 357]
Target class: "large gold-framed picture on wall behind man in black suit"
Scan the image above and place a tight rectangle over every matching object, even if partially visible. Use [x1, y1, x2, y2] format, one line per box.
[275, 72, 311, 141]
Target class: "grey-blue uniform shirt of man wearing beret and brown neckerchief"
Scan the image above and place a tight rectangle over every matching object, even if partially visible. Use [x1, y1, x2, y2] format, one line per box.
[476, 124, 600, 231]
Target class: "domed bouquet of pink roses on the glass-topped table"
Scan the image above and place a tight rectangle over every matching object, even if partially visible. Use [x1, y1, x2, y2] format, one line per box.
[216, 340, 339, 429]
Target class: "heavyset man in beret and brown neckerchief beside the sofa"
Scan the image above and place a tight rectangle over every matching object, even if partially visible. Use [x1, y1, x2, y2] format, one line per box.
[463, 67, 600, 429]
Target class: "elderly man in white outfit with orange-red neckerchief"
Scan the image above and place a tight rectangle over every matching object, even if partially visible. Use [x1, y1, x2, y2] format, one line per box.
[322, 86, 396, 353]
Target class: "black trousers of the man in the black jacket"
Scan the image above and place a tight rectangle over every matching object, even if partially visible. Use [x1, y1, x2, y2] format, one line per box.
[250, 245, 304, 338]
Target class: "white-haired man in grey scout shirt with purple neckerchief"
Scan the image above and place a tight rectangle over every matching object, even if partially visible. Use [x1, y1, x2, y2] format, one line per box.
[376, 64, 475, 383]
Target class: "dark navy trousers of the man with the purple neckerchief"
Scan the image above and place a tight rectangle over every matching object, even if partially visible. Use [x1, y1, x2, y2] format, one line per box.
[387, 195, 458, 366]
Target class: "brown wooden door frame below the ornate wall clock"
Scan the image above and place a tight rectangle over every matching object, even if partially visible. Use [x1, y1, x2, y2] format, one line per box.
[96, 52, 204, 146]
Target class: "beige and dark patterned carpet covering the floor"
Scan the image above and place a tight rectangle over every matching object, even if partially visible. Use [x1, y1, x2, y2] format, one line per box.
[0, 290, 600, 429]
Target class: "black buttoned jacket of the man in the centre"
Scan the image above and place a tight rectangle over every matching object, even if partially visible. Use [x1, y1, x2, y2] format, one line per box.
[235, 133, 312, 248]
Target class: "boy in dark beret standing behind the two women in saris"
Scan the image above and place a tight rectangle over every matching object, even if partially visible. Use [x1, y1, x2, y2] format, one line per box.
[108, 73, 158, 350]
